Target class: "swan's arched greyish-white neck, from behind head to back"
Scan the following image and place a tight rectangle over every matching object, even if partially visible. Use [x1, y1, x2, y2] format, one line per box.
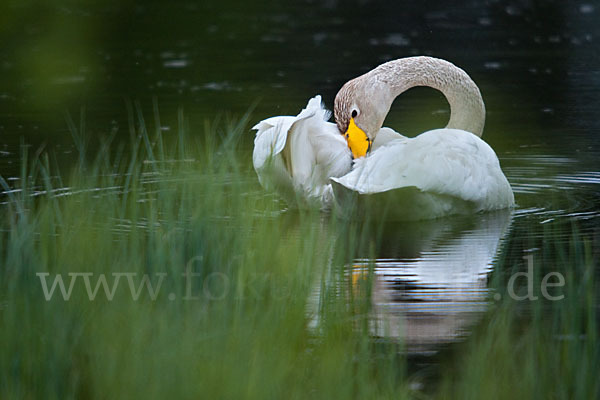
[371, 57, 485, 136]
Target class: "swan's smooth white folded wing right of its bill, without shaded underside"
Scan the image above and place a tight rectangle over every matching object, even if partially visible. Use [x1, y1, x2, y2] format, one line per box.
[335, 129, 514, 209]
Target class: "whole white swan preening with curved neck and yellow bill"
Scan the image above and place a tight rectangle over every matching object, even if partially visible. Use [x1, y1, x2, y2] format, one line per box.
[254, 57, 514, 220]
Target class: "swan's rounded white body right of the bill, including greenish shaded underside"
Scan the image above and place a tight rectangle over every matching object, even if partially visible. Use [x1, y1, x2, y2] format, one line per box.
[334, 129, 514, 219]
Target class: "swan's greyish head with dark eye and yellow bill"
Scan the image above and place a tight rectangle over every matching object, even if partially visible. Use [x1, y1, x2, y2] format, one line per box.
[334, 75, 390, 158]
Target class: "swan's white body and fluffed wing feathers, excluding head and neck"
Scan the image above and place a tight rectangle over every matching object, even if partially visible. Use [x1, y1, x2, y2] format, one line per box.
[253, 96, 514, 220]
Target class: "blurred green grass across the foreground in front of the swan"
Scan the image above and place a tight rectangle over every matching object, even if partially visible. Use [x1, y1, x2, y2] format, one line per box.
[0, 107, 600, 399]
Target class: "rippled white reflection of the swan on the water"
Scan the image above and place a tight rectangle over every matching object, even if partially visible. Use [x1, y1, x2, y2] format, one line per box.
[311, 210, 512, 354]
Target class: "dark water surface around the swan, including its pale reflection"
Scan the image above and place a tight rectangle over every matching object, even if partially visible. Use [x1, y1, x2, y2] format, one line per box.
[0, 0, 600, 354]
